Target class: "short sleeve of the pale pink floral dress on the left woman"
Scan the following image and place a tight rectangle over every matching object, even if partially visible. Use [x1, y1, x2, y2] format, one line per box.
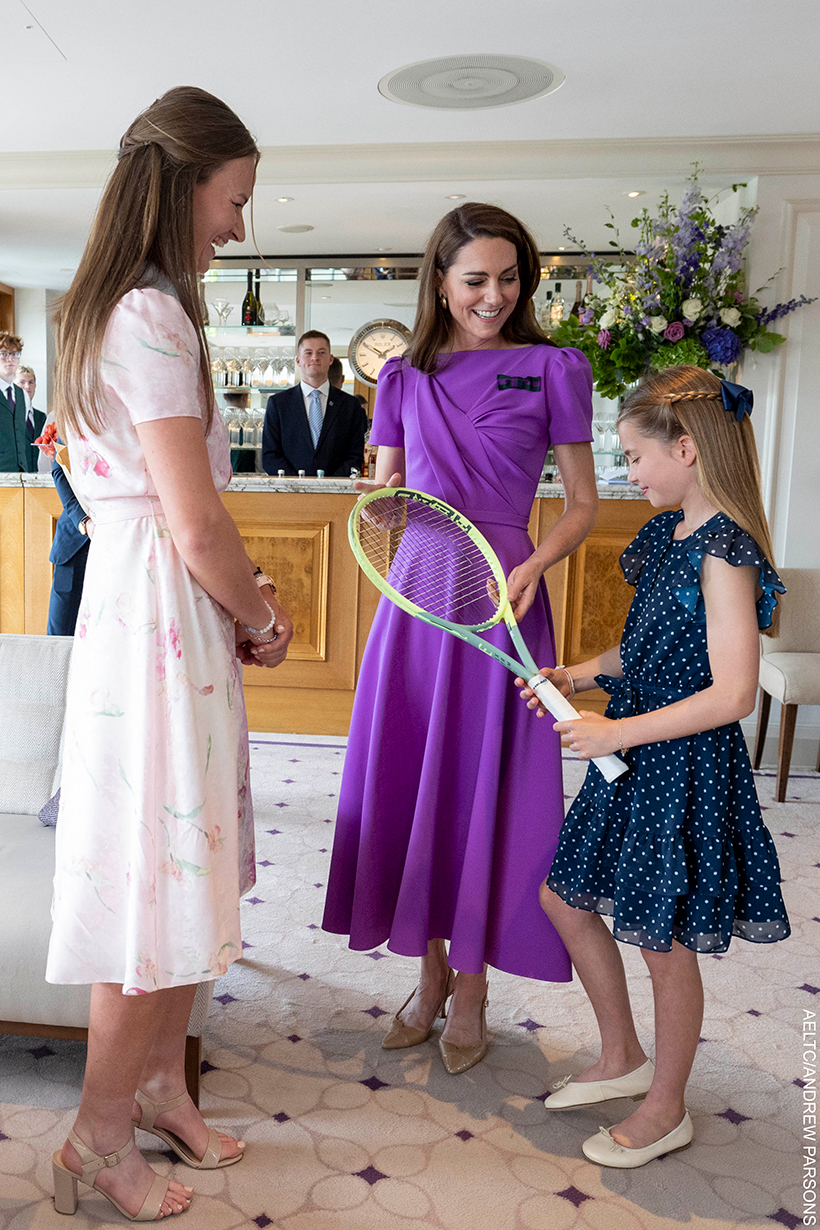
[102, 289, 202, 424]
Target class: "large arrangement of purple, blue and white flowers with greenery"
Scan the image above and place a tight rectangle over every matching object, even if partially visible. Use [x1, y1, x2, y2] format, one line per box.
[551, 166, 815, 397]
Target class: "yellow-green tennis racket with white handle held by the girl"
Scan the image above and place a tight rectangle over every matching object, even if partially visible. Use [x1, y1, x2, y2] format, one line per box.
[348, 487, 628, 781]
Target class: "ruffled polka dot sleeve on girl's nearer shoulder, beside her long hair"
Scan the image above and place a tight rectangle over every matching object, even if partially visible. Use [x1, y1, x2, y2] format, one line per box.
[672, 513, 786, 630]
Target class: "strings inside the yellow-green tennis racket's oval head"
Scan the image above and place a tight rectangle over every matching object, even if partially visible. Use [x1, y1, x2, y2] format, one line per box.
[359, 496, 498, 627]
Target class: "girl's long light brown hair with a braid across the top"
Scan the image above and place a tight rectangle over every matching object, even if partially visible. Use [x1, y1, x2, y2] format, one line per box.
[618, 367, 779, 636]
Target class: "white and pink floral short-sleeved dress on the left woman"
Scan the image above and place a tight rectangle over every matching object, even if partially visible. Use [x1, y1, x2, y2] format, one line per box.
[45, 289, 254, 994]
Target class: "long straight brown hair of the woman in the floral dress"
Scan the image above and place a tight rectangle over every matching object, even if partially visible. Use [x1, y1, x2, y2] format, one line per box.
[54, 86, 259, 433]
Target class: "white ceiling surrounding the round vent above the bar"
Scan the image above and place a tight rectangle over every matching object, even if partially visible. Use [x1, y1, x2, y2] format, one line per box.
[0, 0, 820, 288]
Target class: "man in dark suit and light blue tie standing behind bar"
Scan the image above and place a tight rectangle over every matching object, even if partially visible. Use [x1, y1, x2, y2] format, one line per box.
[262, 330, 366, 478]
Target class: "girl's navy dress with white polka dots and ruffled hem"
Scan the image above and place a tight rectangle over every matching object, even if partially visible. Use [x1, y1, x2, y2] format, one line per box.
[548, 512, 789, 952]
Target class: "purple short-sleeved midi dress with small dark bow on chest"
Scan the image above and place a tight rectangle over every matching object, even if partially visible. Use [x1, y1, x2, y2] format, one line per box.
[323, 346, 591, 982]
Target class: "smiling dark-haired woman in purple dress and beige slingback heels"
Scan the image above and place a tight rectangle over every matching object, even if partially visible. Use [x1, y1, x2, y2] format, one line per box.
[323, 203, 597, 1073]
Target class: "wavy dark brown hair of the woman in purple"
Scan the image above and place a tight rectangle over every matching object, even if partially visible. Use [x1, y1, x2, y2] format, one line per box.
[404, 200, 553, 373]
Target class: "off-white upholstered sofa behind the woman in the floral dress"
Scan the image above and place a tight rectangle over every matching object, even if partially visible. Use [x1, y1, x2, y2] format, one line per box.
[0, 633, 214, 1105]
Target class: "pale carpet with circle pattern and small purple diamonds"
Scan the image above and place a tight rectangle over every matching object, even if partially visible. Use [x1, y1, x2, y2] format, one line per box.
[0, 736, 820, 1230]
